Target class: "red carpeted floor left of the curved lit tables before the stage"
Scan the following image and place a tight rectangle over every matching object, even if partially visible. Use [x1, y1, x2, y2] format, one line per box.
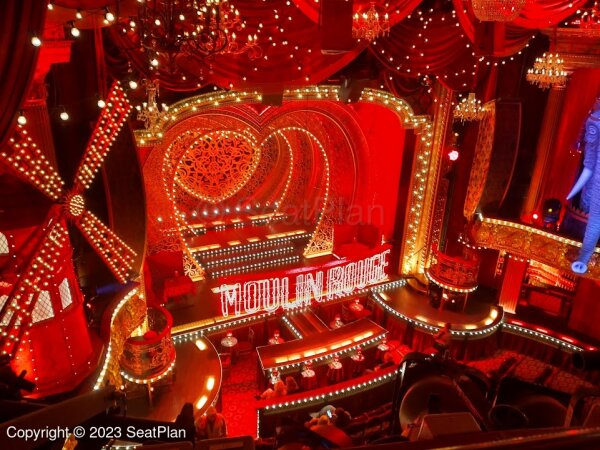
[221, 354, 259, 437]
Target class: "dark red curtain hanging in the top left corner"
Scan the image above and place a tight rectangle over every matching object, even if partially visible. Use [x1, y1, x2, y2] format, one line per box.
[0, 0, 47, 148]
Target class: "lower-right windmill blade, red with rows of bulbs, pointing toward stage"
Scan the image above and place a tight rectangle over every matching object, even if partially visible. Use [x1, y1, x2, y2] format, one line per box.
[75, 211, 136, 283]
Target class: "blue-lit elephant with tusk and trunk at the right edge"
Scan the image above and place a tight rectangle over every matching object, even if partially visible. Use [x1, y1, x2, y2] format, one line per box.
[567, 98, 600, 274]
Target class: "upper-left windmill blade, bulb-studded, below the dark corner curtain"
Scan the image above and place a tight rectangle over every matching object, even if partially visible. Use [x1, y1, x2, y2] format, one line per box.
[0, 125, 64, 200]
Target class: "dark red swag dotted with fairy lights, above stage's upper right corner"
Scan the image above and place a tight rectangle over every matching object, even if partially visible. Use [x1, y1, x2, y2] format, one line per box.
[369, 11, 476, 90]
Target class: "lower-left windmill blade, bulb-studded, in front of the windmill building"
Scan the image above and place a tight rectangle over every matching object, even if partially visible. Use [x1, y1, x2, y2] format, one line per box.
[0, 219, 68, 355]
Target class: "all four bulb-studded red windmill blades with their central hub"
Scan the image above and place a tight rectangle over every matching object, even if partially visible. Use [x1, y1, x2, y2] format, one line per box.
[0, 83, 136, 356]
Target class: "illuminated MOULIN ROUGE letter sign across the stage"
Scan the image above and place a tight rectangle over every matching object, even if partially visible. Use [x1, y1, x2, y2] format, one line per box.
[219, 246, 390, 317]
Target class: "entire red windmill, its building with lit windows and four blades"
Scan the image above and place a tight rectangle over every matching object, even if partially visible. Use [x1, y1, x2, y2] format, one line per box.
[0, 83, 136, 393]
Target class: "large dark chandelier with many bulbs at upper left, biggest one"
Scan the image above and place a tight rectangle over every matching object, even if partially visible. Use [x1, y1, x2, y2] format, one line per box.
[135, 0, 262, 70]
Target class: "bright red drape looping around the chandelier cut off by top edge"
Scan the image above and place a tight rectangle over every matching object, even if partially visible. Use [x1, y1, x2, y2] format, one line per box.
[452, 0, 585, 57]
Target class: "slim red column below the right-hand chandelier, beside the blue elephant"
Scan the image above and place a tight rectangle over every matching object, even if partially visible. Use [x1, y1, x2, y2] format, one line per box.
[521, 86, 566, 215]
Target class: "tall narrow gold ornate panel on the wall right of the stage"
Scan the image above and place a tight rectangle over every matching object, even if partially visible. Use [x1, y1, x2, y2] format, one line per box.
[463, 101, 496, 220]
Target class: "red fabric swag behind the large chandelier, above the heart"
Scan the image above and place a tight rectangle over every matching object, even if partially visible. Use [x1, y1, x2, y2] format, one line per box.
[109, 0, 366, 91]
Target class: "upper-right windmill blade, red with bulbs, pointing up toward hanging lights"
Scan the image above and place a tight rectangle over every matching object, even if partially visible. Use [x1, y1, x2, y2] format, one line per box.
[75, 82, 132, 192]
